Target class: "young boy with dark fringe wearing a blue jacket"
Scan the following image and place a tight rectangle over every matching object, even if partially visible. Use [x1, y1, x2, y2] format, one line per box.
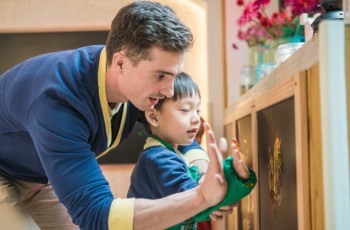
[128, 73, 255, 229]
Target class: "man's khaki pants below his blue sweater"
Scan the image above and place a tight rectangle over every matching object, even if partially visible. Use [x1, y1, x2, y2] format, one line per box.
[0, 174, 79, 230]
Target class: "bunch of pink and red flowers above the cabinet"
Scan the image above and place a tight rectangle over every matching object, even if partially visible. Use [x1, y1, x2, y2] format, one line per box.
[232, 0, 320, 49]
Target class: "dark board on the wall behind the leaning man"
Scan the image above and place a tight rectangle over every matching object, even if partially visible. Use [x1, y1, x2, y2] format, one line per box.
[0, 31, 146, 164]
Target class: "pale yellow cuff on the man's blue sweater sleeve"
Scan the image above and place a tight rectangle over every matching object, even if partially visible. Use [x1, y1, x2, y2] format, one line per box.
[108, 198, 135, 230]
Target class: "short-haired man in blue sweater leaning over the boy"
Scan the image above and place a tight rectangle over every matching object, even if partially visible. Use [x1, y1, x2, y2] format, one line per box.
[0, 1, 249, 229]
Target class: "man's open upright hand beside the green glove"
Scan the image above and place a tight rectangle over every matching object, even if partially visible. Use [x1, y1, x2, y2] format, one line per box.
[199, 122, 227, 206]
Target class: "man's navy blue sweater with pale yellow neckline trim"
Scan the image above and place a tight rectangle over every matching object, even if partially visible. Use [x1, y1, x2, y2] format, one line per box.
[0, 46, 202, 229]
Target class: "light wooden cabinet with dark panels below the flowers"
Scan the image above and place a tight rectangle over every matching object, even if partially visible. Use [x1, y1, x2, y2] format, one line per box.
[224, 38, 324, 230]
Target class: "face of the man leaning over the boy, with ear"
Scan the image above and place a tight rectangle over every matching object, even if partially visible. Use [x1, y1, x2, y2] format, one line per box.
[109, 48, 184, 111]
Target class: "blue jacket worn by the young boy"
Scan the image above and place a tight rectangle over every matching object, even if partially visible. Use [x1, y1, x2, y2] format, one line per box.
[128, 137, 198, 199]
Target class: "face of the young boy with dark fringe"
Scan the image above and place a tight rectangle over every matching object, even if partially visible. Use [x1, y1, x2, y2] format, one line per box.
[152, 94, 201, 147]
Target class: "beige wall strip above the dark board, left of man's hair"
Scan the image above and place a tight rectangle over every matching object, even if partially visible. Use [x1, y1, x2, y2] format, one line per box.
[0, 0, 131, 32]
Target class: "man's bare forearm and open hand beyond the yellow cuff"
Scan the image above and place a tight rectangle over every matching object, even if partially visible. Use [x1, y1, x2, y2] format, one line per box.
[133, 125, 227, 229]
